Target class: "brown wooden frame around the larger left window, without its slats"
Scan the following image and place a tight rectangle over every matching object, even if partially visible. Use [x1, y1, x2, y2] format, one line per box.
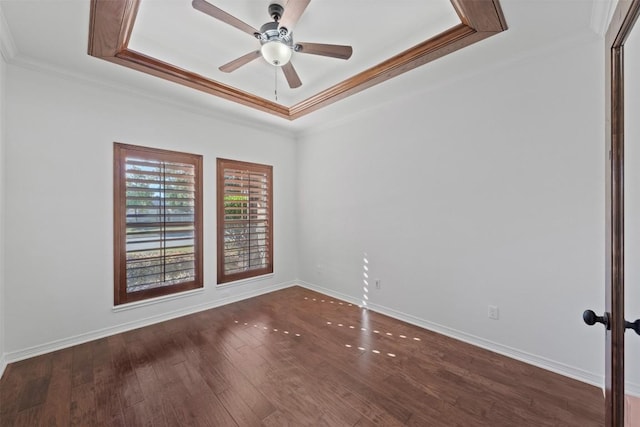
[113, 142, 204, 305]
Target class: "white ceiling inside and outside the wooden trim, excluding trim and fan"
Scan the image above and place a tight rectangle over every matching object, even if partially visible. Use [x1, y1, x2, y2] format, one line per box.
[0, 0, 613, 132]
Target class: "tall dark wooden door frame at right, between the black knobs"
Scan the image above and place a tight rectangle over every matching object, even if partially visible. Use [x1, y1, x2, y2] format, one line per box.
[605, 0, 640, 427]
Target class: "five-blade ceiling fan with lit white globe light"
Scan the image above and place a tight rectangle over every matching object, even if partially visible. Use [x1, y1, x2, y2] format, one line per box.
[192, 0, 353, 89]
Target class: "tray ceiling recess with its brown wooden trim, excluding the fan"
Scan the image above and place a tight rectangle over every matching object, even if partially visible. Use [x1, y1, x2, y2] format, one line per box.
[89, 0, 506, 120]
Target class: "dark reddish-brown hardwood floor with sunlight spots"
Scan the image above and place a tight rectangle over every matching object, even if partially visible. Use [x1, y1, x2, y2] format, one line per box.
[0, 287, 604, 427]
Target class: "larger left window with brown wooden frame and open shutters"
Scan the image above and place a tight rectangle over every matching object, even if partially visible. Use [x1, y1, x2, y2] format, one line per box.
[114, 143, 203, 305]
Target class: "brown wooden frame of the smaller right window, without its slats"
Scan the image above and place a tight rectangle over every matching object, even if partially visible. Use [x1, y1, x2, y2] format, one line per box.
[216, 158, 273, 285]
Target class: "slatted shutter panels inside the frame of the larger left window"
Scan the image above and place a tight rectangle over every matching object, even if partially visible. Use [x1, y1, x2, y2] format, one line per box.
[126, 157, 195, 292]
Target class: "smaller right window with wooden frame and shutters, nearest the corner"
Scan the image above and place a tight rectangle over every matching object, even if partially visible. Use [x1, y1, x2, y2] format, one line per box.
[217, 159, 273, 283]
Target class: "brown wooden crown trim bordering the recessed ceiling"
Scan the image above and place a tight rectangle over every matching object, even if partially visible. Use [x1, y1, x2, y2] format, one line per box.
[88, 0, 507, 120]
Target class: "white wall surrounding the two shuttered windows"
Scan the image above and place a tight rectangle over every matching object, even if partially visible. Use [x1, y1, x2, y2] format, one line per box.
[5, 65, 297, 360]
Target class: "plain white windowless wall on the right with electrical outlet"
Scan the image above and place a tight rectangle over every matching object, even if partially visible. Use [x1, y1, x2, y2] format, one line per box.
[298, 41, 605, 383]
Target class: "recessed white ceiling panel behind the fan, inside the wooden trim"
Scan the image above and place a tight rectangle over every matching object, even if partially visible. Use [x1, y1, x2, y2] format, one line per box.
[129, 0, 460, 106]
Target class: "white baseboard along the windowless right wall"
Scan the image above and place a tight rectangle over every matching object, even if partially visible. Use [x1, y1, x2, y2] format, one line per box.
[297, 280, 640, 396]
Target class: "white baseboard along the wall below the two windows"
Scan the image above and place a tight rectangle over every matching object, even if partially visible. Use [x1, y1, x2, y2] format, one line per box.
[0, 281, 297, 371]
